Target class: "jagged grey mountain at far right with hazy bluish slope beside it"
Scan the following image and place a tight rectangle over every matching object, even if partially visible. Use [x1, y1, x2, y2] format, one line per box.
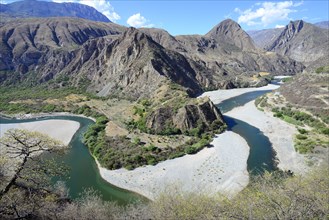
[249, 20, 329, 67]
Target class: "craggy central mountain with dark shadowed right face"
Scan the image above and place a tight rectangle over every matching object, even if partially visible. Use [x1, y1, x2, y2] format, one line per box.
[62, 28, 202, 98]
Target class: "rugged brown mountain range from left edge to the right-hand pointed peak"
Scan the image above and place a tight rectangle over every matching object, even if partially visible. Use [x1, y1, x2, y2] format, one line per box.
[0, 18, 304, 96]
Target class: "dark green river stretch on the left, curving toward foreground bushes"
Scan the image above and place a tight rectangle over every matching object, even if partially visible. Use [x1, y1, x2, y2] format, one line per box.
[0, 116, 146, 205]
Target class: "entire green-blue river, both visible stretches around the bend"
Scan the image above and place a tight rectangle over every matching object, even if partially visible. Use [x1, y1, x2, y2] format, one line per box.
[0, 84, 275, 204]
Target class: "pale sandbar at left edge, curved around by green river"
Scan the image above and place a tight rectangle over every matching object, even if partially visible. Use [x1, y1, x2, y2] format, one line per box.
[0, 120, 80, 145]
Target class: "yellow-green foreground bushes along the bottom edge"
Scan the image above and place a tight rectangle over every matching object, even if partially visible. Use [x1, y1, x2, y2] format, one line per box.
[1, 165, 329, 220]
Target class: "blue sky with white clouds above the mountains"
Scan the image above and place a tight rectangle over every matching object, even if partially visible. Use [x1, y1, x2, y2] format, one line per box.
[0, 0, 329, 35]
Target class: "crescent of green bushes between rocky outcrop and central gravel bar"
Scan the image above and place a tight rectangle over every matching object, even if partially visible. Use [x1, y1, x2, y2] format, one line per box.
[84, 132, 211, 170]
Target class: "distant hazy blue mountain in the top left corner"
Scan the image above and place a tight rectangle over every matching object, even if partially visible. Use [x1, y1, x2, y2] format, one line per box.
[0, 0, 110, 22]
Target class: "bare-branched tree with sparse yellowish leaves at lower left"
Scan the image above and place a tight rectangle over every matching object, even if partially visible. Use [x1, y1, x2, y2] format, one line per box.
[0, 129, 64, 218]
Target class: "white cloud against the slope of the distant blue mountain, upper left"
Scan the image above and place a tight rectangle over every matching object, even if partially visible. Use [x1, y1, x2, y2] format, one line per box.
[52, 0, 121, 22]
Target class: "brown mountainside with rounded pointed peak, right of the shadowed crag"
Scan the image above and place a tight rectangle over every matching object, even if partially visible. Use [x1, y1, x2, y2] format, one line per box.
[142, 19, 303, 89]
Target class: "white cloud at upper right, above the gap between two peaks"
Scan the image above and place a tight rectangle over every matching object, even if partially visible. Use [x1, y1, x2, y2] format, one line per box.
[234, 1, 303, 27]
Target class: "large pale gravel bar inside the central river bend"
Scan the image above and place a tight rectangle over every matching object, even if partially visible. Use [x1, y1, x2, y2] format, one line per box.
[99, 131, 249, 199]
